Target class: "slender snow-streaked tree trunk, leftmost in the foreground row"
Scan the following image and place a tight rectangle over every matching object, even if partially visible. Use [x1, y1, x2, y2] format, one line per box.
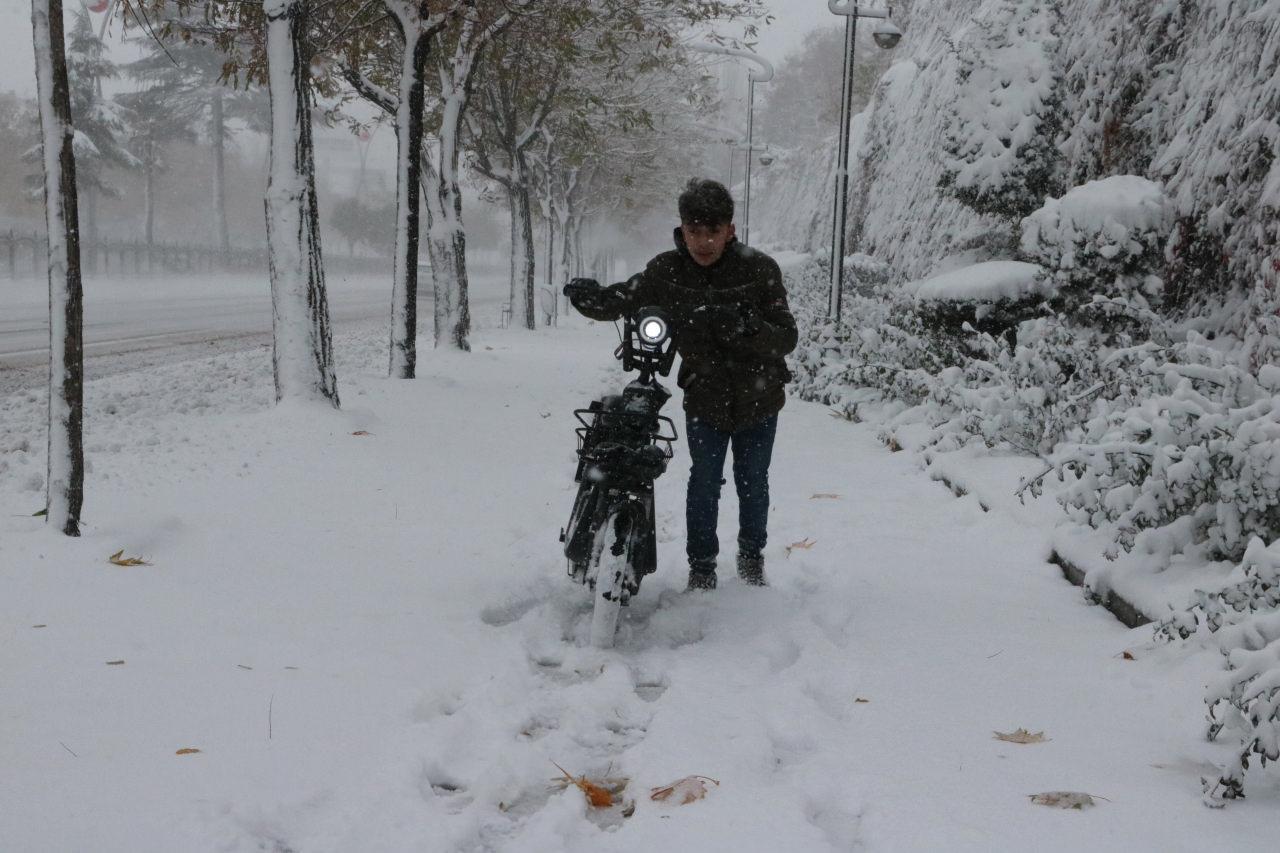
[31, 0, 84, 537]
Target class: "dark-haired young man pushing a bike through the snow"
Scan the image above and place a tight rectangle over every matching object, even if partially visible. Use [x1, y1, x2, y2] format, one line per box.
[564, 178, 796, 589]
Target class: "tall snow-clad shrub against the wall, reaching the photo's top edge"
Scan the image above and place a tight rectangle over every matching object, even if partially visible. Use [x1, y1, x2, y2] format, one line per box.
[940, 0, 1062, 222]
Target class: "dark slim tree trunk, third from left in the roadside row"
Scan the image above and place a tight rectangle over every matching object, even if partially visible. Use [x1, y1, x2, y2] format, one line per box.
[388, 22, 430, 379]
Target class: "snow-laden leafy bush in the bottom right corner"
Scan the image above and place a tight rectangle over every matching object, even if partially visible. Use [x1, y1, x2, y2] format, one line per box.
[1156, 538, 1280, 806]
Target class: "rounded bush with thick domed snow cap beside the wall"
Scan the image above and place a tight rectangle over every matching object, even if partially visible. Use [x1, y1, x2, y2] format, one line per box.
[1020, 174, 1172, 327]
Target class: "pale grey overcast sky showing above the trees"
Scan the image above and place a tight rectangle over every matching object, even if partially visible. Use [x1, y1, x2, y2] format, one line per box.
[0, 0, 844, 95]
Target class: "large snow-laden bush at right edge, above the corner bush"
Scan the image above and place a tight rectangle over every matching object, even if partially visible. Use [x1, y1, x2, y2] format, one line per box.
[1055, 332, 1280, 560]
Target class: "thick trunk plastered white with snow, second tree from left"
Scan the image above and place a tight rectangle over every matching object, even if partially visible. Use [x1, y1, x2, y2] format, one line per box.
[262, 0, 338, 407]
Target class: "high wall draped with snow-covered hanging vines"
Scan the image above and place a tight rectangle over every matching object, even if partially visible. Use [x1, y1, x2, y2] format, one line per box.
[753, 0, 1280, 313]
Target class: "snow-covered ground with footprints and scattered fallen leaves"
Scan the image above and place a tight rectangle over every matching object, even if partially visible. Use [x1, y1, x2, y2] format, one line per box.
[0, 313, 1280, 853]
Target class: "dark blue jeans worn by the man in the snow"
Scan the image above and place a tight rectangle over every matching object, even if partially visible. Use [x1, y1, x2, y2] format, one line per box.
[685, 415, 778, 560]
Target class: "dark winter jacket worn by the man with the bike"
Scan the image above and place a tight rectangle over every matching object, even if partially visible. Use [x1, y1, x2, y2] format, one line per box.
[580, 228, 796, 432]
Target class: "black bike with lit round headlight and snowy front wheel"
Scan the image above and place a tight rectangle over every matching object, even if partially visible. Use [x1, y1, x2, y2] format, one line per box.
[561, 302, 680, 648]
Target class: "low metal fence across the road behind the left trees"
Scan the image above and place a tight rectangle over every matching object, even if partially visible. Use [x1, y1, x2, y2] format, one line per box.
[0, 231, 392, 279]
